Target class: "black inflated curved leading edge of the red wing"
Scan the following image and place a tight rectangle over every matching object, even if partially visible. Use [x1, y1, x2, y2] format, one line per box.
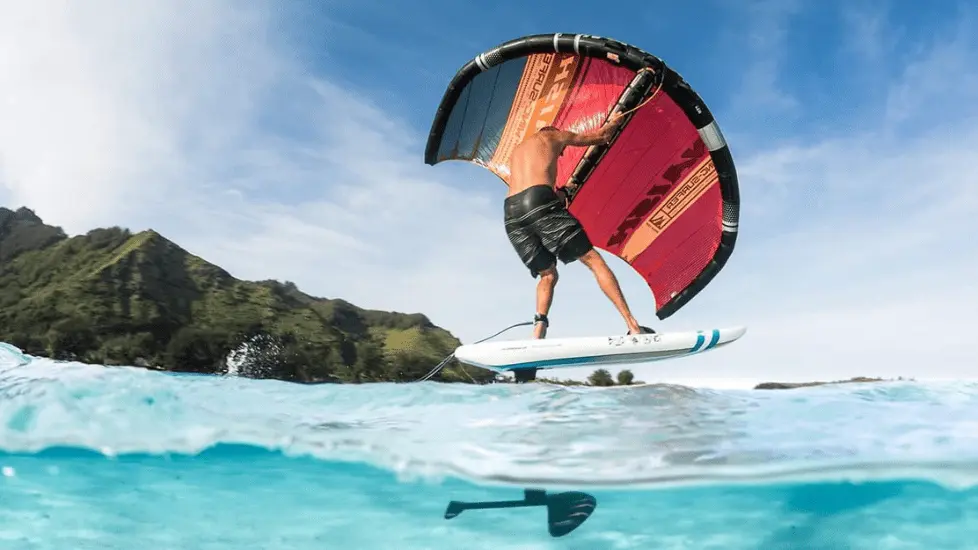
[424, 33, 740, 319]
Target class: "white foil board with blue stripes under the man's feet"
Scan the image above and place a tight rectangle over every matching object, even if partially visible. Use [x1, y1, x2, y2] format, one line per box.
[455, 326, 747, 372]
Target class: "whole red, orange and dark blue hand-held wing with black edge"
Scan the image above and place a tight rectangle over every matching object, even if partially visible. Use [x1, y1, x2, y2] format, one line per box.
[425, 33, 740, 319]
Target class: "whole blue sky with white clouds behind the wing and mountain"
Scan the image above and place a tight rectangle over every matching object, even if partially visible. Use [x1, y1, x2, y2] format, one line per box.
[0, 0, 978, 386]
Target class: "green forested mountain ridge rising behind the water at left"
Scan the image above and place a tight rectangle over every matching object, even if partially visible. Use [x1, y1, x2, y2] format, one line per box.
[0, 208, 492, 382]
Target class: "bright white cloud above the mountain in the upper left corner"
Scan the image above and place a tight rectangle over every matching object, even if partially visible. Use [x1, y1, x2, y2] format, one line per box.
[0, 0, 285, 231]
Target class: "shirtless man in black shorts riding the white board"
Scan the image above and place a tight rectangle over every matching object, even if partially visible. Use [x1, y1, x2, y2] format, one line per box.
[504, 115, 652, 338]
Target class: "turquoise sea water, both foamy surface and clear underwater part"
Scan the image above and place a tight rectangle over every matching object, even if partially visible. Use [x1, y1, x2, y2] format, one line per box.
[0, 345, 978, 550]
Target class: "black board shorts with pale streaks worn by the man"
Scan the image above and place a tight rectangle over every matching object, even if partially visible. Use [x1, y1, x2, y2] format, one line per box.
[503, 185, 594, 277]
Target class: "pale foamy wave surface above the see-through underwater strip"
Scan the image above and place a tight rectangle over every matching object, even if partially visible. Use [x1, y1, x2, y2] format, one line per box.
[0, 348, 978, 494]
